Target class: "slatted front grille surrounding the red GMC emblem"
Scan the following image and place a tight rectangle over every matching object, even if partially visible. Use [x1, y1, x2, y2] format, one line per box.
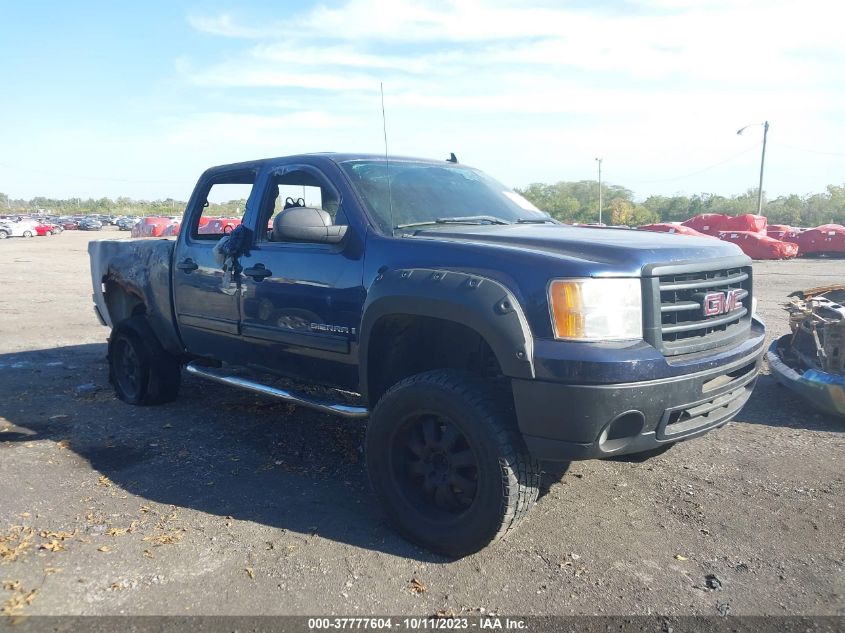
[643, 262, 752, 356]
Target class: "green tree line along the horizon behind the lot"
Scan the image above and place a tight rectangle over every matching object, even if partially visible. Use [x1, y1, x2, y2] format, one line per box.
[0, 180, 845, 227]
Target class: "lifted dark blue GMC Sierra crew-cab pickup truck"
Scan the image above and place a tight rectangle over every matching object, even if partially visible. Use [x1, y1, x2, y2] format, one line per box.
[89, 153, 764, 556]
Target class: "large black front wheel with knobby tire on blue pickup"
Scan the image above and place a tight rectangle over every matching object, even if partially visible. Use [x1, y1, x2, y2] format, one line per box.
[366, 370, 540, 557]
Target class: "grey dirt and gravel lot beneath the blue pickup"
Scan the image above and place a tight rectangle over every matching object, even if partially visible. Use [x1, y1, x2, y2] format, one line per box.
[0, 232, 845, 615]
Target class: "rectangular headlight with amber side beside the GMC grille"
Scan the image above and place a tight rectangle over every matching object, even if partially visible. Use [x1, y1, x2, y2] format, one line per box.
[549, 279, 643, 341]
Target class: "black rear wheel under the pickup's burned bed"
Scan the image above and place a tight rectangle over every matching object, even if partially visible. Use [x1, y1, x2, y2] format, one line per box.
[109, 316, 182, 405]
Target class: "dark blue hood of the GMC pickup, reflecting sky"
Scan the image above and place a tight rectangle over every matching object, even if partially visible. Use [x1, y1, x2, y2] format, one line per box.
[415, 224, 742, 275]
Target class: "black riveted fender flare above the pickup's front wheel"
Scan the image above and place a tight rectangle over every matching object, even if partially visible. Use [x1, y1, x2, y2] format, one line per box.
[358, 268, 535, 394]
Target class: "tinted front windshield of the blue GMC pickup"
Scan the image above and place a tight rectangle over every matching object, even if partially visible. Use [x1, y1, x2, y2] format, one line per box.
[340, 160, 549, 233]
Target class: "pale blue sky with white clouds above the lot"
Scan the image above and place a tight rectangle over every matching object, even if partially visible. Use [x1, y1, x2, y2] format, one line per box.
[0, 0, 845, 200]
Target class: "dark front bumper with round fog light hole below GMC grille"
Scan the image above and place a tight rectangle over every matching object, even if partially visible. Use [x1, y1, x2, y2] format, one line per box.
[512, 325, 764, 461]
